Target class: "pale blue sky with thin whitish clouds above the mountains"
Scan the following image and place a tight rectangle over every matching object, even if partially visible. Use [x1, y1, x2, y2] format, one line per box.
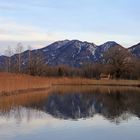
[0, 0, 140, 54]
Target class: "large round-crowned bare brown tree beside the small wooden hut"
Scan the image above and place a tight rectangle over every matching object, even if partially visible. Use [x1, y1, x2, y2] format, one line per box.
[104, 45, 133, 79]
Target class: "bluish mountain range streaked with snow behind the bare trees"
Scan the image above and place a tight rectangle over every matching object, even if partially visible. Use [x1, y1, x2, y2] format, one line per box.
[0, 40, 140, 67]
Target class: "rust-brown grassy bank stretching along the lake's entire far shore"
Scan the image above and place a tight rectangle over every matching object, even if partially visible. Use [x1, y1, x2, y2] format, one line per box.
[0, 73, 140, 95]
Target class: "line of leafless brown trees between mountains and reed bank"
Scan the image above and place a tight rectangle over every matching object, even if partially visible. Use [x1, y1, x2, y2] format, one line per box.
[1, 43, 140, 79]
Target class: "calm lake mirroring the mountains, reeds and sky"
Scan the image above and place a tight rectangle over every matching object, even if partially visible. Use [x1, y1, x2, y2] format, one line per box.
[0, 86, 140, 140]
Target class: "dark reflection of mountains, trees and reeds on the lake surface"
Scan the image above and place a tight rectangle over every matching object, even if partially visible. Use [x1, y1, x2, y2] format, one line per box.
[0, 86, 140, 122]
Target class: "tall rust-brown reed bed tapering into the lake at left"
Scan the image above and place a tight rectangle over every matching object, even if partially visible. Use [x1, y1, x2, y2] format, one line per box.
[0, 73, 50, 93]
